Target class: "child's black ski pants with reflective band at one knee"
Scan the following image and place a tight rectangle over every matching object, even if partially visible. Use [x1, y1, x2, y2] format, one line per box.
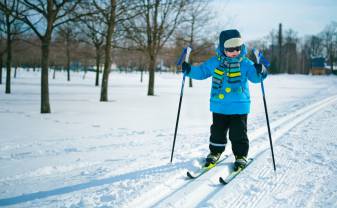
[209, 113, 249, 157]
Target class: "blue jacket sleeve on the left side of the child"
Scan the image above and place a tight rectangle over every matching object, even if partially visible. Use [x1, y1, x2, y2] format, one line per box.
[187, 56, 217, 80]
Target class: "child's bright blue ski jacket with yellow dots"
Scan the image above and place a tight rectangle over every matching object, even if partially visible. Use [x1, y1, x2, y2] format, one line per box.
[187, 45, 266, 115]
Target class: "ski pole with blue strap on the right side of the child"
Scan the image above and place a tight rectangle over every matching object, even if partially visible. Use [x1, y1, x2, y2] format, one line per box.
[253, 48, 276, 171]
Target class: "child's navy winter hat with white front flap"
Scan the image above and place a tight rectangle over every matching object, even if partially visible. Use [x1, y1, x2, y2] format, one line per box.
[219, 29, 243, 51]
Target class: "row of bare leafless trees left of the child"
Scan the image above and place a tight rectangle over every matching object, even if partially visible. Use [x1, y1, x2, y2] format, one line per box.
[0, 0, 218, 113]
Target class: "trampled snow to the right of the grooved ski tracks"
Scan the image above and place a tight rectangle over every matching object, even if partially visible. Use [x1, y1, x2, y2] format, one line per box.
[208, 100, 337, 208]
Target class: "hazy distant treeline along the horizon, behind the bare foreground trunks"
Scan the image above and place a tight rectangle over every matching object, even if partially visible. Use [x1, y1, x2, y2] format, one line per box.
[2, 22, 337, 74]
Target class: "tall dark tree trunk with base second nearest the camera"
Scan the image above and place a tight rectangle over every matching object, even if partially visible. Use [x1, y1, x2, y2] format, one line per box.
[100, 0, 116, 102]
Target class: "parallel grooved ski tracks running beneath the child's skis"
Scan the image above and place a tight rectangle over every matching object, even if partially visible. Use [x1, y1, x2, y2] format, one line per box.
[126, 96, 337, 207]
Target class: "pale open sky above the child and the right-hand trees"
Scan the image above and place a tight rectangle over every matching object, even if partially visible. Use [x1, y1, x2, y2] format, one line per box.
[210, 0, 337, 40]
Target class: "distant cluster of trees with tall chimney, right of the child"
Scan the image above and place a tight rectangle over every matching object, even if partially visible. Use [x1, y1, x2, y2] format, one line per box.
[252, 22, 337, 74]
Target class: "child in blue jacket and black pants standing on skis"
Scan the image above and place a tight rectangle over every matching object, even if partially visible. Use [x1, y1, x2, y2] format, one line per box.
[182, 30, 267, 170]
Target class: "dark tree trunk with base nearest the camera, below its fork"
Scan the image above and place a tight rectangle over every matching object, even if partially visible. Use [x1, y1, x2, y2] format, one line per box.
[41, 38, 50, 113]
